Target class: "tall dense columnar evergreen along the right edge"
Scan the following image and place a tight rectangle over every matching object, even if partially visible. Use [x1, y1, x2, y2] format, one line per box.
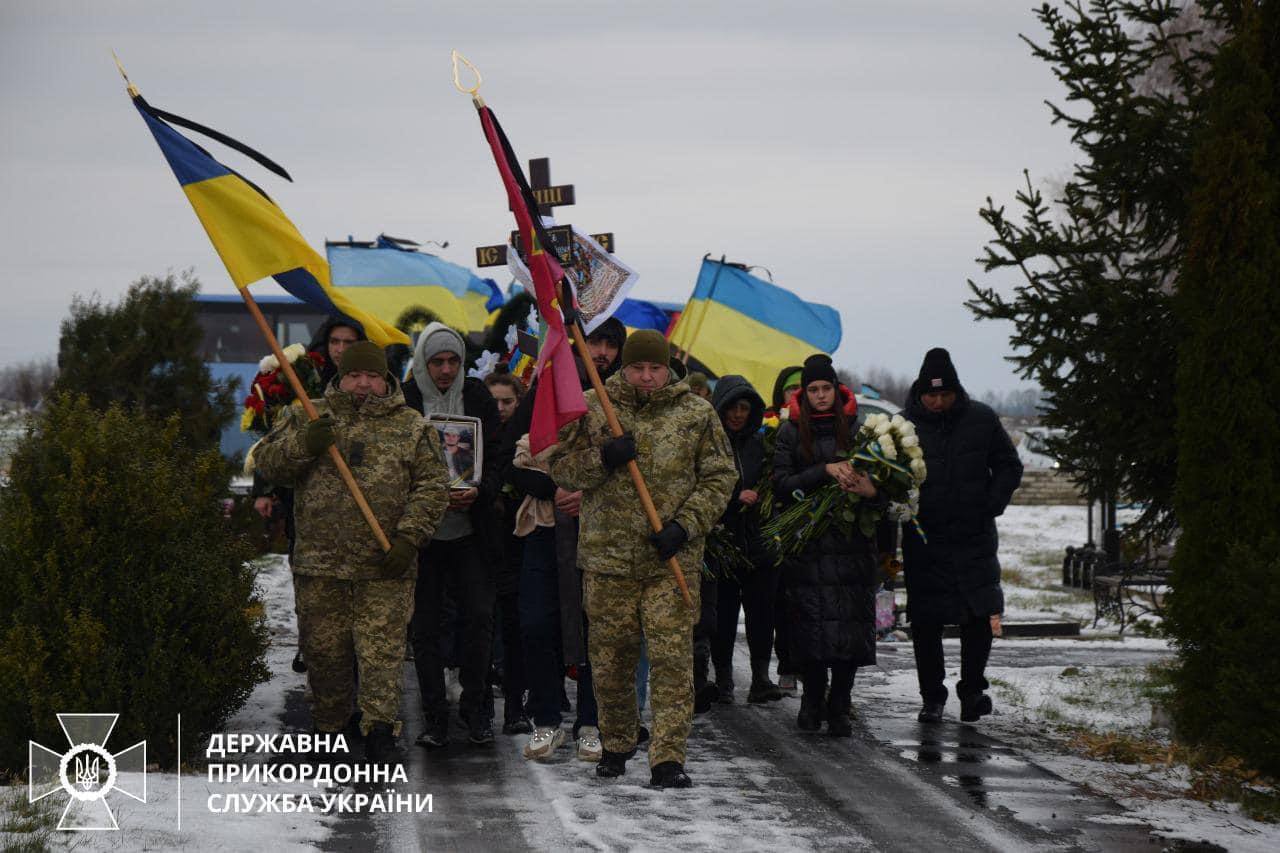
[1167, 3, 1280, 775]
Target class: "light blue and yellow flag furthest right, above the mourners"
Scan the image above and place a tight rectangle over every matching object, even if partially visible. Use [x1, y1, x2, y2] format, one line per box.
[671, 259, 841, 388]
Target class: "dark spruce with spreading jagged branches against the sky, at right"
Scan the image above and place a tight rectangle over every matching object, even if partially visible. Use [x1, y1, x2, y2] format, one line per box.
[966, 0, 1217, 535]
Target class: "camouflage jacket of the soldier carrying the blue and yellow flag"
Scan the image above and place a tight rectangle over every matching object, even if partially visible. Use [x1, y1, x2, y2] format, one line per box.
[253, 380, 449, 579]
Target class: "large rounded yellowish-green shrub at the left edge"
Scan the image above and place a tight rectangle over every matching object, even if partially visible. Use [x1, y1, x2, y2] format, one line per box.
[0, 394, 268, 774]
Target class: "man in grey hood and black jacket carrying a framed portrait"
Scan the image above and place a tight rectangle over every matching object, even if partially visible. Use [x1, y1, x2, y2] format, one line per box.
[404, 323, 500, 748]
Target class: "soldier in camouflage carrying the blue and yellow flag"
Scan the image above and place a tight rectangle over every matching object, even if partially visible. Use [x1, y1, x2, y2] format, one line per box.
[255, 341, 448, 762]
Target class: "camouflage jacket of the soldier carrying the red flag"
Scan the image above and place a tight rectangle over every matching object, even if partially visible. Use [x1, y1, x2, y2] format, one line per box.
[550, 373, 737, 583]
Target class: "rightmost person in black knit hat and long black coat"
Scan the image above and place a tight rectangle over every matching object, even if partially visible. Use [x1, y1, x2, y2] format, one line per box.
[902, 348, 1023, 722]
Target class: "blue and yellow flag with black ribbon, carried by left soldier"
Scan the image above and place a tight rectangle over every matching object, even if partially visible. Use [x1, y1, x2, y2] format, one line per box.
[129, 76, 410, 346]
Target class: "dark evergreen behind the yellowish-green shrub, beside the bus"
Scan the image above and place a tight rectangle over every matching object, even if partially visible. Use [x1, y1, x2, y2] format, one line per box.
[54, 275, 236, 447]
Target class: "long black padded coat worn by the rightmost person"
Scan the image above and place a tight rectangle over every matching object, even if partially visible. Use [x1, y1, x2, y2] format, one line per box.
[902, 387, 1023, 625]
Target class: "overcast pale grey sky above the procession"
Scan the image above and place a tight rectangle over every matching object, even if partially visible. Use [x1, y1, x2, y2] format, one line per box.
[0, 0, 1073, 391]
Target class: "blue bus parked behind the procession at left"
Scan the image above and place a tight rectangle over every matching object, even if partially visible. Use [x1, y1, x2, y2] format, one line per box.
[196, 293, 325, 457]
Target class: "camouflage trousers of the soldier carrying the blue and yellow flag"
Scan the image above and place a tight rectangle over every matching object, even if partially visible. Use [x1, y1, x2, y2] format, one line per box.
[293, 574, 413, 734]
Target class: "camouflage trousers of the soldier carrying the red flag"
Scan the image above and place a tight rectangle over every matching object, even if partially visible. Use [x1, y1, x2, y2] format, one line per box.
[582, 573, 699, 767]
